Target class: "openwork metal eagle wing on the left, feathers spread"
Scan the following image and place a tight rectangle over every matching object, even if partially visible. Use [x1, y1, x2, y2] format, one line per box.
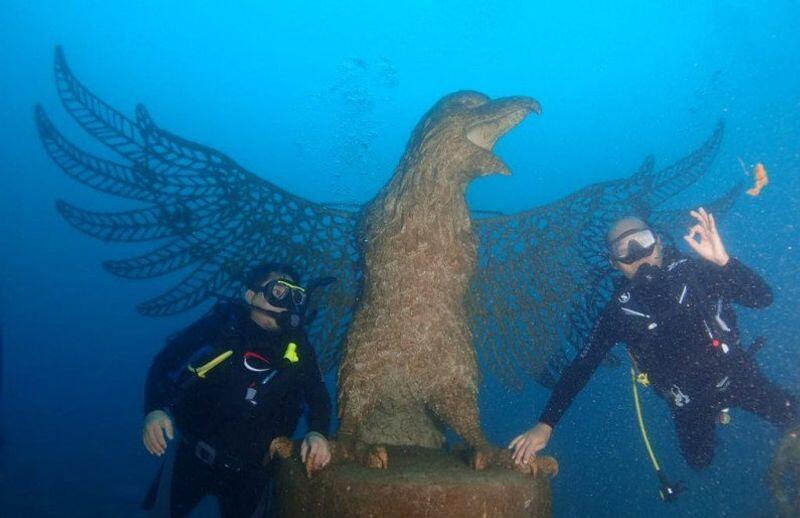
[36, 48, 362, 368]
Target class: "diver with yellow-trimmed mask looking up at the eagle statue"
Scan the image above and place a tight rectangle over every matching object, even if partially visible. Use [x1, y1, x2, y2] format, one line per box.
[142, 263, 331, 518]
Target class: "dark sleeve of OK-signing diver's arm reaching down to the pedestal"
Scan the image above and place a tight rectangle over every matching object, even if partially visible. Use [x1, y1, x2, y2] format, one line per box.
[539, 306, 620, 428]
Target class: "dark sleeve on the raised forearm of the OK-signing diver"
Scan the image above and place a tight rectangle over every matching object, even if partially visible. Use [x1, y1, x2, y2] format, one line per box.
[703, 257, 772, 308]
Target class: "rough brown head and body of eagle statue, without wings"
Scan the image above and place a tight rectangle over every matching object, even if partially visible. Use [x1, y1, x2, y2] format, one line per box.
[339, 92, 538, 447]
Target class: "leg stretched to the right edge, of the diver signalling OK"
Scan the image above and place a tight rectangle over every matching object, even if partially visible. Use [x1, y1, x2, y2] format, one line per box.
[730, 361, 800, 428]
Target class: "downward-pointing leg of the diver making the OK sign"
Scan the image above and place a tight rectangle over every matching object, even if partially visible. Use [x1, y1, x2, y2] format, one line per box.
[672, 401, 717, 471]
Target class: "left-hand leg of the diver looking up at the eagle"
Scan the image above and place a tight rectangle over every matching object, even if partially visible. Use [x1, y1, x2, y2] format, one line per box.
[169, 442, 213, 518]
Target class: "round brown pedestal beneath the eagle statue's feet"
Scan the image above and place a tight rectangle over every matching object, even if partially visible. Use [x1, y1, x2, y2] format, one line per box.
[273, 447, 552, 518]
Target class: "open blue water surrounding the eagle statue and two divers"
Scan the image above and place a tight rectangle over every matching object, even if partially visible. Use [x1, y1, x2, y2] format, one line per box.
[0, 0, 800, 517]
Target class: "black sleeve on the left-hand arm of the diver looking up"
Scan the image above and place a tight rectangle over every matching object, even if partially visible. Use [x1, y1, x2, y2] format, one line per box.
[144, 311, 220, 415]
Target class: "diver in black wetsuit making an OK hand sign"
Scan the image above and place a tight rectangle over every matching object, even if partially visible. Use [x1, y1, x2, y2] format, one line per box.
[509, 208, 798, 470]
